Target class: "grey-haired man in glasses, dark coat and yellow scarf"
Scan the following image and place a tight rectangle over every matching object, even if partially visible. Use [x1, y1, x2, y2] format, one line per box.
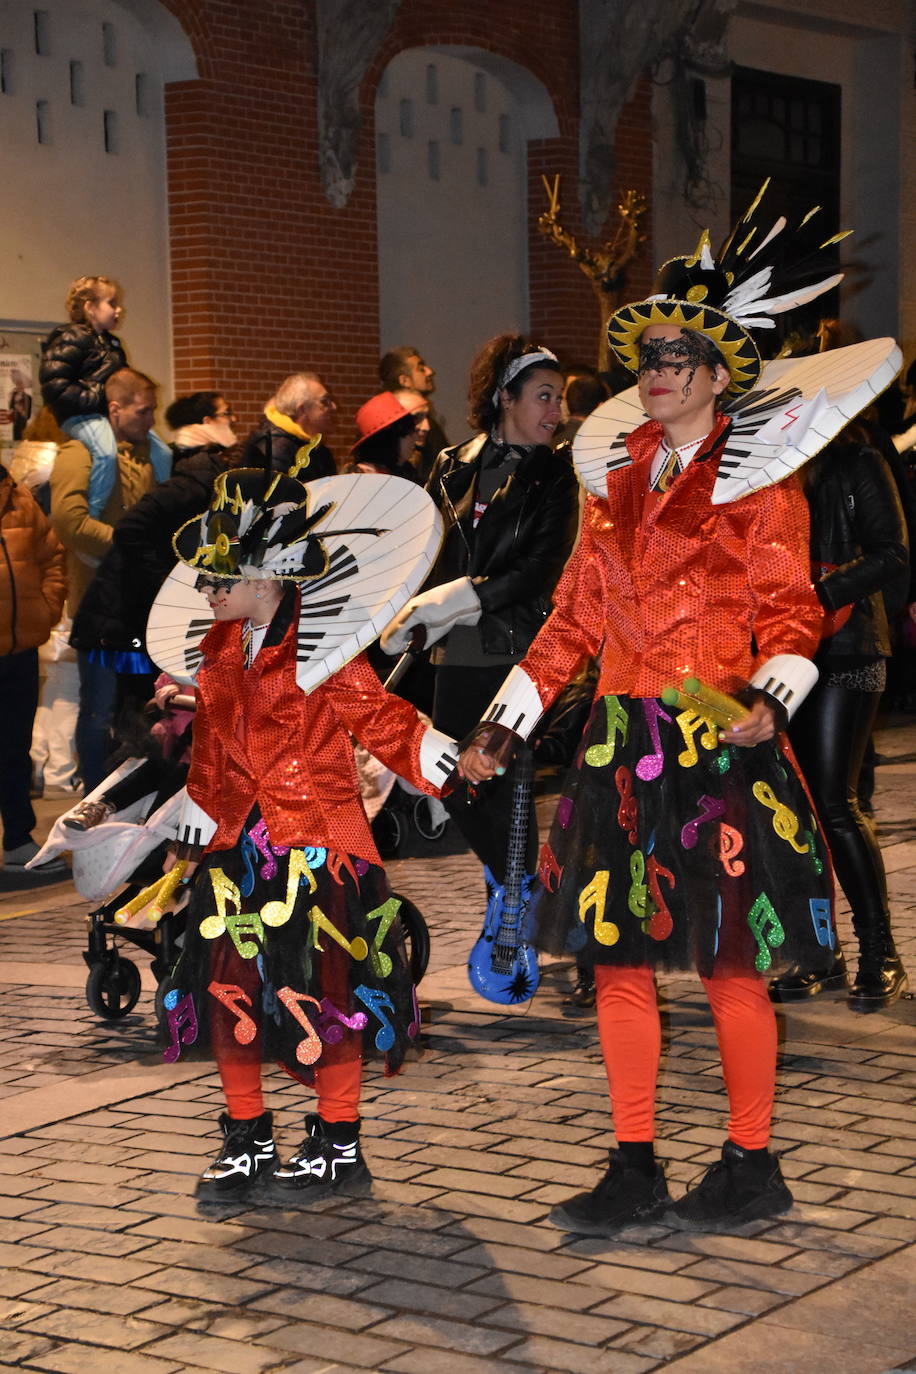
[242, 372, 336, 482]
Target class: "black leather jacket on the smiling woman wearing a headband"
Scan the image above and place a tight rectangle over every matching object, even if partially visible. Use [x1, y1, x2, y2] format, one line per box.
[427, 434, 578, 658]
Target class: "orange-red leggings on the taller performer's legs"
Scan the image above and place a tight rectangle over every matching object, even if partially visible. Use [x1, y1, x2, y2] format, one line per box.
[595, 965, 776, 1150]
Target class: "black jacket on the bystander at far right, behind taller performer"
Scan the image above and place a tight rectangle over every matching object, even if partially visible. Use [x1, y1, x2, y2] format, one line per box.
[805, 441, 909, 661]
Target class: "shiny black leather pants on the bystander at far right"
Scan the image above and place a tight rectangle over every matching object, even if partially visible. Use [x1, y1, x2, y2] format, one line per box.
[790, 686, 889, 941]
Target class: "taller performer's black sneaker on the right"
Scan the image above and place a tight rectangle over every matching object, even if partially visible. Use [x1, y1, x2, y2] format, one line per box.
[665, 1140, 792, 1231]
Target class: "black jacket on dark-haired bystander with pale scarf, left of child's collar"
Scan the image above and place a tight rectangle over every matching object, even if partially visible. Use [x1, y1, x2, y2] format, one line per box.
[70, 444, 227, 650]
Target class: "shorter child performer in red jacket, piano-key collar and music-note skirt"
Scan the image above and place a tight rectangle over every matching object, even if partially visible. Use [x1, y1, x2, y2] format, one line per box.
[148, 456, 456, 1200]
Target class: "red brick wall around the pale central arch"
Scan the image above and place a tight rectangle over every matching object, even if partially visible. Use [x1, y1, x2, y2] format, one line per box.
[165, 0, 651, 431]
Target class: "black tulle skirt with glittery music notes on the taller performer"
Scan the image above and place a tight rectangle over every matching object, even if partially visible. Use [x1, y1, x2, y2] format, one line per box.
[536, 697, 835, 977]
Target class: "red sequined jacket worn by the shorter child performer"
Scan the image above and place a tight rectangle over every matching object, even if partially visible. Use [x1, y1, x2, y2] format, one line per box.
[180, 618, 453, 863]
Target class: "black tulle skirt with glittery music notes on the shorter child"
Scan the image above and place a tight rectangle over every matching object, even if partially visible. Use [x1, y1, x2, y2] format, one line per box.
[163, 816, 419, 1081]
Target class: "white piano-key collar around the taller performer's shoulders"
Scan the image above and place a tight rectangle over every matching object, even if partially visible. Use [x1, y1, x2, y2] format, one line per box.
[573, 338, 902, 506]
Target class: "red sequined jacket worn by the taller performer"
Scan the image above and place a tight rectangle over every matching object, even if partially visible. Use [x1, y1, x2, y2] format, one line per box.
[520, 416, 823, 709]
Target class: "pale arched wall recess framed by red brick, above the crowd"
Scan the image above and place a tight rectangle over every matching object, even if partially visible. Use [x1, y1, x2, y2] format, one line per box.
[375, 44, 559, 440]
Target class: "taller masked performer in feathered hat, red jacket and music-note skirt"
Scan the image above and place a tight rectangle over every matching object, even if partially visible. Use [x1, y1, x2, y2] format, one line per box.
[461, 182, 895, 1234]
